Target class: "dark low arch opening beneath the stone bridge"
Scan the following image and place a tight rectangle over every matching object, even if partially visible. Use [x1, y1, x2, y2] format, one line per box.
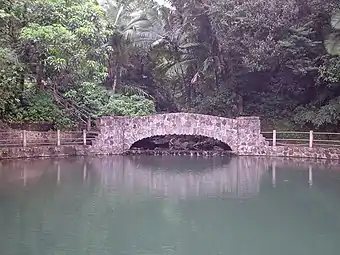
[129, 135, 232, 152]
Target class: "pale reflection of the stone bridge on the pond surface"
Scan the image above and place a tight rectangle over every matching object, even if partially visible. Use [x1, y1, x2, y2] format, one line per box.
[91, 157, 268, 198]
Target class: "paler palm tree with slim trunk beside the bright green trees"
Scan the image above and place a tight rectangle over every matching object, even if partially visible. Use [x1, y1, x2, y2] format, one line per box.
[101, 0, 162, 92]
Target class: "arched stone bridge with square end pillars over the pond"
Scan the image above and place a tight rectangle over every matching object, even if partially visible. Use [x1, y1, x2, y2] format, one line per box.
[92, 113, 268, 155]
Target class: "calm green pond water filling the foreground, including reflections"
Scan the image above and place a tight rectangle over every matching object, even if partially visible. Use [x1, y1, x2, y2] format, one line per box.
[0, 156, 340, 255]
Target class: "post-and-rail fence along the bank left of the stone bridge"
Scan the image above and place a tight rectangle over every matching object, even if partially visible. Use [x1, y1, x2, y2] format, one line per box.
[0, 130, 98, 148]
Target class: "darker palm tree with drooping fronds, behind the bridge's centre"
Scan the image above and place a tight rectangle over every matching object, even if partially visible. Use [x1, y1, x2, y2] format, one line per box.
[152, 2, 221, 105]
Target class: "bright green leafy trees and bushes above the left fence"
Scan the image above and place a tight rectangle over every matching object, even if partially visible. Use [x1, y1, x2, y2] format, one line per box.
[0, 0, 154, 127]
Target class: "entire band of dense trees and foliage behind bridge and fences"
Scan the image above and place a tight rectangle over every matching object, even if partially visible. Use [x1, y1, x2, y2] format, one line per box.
[0, 0, 340, 130]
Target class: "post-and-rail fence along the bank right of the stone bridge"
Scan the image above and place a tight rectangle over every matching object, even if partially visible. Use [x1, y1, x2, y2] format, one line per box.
[261, 130, 340, 148]
